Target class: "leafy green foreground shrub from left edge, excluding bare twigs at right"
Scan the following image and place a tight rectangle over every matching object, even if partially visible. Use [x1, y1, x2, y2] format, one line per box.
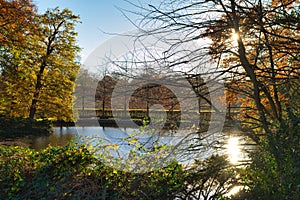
[0, 144, 185, 199]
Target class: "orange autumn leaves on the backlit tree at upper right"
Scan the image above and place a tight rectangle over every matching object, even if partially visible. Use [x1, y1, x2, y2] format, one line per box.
[211, 0, 300, 123]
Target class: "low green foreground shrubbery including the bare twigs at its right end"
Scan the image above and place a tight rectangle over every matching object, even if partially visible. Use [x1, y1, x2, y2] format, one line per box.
[0, 144, 237, 199]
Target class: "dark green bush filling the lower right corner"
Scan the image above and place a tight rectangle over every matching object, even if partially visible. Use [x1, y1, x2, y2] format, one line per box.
[237, 126, 300, 200]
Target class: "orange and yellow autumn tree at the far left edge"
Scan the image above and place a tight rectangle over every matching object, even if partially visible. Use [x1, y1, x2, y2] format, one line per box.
[0, 0, 36, 116]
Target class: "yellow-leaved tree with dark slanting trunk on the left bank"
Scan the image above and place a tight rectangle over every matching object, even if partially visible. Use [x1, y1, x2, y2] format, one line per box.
[29, 8, 79, 119]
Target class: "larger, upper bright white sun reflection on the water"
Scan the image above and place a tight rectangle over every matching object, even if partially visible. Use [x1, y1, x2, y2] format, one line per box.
[226, 137, 242, 164]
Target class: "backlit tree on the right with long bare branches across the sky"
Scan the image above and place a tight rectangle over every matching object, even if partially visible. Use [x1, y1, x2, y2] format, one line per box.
[122, 0, 300, 198]
